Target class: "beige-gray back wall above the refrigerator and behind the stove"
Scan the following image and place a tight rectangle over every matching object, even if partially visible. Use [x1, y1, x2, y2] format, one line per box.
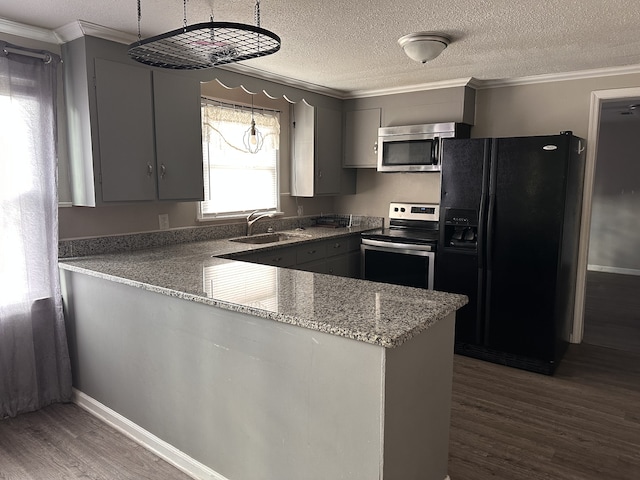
[336, 74, 640, 217]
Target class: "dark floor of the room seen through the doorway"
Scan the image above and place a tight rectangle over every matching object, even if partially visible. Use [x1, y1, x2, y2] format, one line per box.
[583, 271, 640, 354]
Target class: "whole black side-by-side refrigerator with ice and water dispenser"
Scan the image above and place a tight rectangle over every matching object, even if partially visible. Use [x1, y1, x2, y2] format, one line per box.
[435, 132, 585, 375]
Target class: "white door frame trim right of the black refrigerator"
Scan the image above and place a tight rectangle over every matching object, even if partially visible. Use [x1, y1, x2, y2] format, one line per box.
[570, 87, 640, 343]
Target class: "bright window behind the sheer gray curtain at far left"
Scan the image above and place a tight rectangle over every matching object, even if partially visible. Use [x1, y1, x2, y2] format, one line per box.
[0, 64, 57, 313]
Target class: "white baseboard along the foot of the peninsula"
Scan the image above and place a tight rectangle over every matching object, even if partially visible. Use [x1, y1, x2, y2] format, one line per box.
[72, 389, 228, 480]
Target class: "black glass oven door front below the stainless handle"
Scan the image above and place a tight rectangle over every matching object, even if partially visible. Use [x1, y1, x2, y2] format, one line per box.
[362, 247, 434, 289]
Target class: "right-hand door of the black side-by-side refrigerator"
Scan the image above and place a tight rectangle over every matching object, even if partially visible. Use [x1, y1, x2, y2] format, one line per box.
[485, 135, 571, 360]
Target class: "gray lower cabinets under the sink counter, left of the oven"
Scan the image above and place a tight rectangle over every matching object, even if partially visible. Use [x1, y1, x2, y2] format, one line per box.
[231, 235, 360, 278]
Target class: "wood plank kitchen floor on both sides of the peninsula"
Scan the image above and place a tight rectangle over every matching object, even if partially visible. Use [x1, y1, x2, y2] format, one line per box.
[0, 344, 640, 480]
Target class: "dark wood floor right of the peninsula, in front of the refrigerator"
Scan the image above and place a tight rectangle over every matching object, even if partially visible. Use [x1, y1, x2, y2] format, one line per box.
[449, 344, 640, 480]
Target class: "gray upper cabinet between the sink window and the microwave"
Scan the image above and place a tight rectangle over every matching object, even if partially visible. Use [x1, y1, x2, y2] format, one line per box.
[291, 102, 355, 197]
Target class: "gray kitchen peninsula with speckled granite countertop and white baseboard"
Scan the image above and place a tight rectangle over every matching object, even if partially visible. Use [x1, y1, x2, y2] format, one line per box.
[60, 223, 466, 480]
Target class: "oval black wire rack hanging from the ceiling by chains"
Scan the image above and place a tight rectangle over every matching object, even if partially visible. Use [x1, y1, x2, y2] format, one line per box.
[129, 0, 280, 70]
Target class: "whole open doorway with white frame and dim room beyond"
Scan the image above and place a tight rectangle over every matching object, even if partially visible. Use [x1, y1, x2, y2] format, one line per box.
[573, 88, 640, 353]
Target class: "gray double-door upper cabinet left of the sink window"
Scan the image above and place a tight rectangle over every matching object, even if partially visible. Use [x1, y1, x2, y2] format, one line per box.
[63, 37, 203, 206]
